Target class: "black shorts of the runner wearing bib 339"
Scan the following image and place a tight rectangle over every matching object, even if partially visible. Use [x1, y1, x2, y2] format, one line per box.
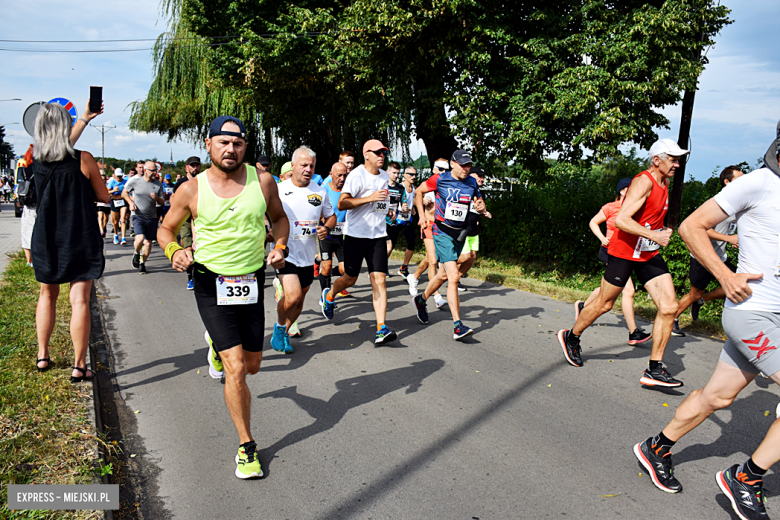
[192, 263, 266, 352]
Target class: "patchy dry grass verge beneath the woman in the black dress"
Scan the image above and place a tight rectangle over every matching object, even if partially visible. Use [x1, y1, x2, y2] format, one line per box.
[0, 253, 107, 519]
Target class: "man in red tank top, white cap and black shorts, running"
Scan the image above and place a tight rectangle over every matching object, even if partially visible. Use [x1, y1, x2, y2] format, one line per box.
[558, 139, 690, 388]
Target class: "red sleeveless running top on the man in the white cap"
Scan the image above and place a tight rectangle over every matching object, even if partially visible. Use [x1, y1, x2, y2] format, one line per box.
[608, 170, 669, 262]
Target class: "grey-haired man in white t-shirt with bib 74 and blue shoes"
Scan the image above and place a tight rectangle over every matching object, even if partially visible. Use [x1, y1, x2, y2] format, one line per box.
[271, 146, 336, 354]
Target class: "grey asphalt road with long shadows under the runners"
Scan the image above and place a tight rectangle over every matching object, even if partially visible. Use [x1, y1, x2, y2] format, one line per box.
[98, 237, 780, 520]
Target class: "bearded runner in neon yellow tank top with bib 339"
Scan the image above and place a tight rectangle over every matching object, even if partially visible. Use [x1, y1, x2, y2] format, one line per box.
[157, 116, 290, 479]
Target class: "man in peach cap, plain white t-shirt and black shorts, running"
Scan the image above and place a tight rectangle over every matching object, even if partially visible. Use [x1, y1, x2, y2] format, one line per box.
[322, 139, 398, 345]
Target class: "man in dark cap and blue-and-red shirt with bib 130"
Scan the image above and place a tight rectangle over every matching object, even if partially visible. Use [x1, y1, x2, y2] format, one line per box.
[414, 150, 486, 339]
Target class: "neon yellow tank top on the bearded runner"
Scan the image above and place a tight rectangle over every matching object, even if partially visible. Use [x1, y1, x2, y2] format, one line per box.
[192, 165, 266, 276]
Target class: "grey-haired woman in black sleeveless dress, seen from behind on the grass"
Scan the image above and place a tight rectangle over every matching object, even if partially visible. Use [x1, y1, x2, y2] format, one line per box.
[31, 103, 108, 383]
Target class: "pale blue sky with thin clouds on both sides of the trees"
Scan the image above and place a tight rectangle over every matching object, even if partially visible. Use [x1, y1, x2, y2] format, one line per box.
[0, 0, 780, 179]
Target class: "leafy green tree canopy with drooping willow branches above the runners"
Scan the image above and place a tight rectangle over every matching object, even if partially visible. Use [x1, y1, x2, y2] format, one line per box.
[131, 0, 729, 179]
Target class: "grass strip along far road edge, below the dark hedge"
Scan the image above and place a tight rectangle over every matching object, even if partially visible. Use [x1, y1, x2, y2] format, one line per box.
[392, 250, 726, 340]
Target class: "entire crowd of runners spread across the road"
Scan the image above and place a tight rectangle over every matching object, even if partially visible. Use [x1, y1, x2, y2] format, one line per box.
[88, 116, 780, 519]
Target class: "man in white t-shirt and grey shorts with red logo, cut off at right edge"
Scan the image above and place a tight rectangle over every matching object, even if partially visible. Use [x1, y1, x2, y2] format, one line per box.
[634, 139, 780, 518]
